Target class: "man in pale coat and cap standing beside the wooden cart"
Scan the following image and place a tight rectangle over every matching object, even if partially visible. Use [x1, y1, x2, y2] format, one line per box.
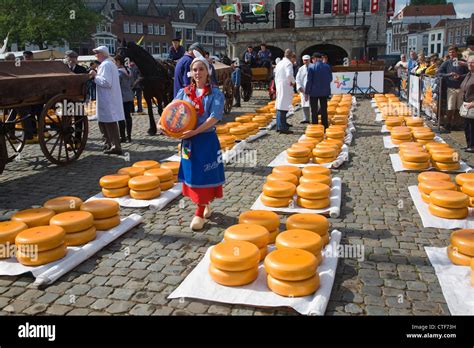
[89, 46, 125, 155]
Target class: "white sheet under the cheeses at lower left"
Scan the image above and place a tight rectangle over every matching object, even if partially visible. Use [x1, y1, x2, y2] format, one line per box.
[0, 214, 143, 285]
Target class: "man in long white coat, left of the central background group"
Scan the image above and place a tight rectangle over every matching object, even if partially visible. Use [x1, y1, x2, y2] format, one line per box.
[274, 49, 295, 134]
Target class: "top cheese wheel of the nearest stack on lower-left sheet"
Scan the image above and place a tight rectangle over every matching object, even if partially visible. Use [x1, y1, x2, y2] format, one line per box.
[15, 226, 66, 253]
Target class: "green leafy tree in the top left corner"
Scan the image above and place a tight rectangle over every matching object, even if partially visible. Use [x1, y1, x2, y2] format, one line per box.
[0, 0, 101, 49]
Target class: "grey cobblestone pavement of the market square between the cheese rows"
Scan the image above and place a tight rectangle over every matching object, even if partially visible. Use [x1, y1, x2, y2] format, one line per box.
[0, 92, 469, 315]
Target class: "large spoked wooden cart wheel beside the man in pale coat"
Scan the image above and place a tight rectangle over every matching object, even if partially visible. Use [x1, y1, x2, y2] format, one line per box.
[38, 95, 89, 165]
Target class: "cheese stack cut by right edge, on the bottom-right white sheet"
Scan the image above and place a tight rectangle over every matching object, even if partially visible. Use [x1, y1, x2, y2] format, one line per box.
[447, 229, 474, 267]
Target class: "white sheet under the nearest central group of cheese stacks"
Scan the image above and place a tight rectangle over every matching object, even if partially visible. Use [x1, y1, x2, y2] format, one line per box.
[168, 230, 341, 315]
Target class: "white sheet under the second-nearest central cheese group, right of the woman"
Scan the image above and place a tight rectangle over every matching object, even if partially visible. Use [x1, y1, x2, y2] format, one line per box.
[250, 177, 342, 218]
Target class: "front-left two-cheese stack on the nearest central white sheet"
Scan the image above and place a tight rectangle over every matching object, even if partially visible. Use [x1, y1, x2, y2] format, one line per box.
[209, 240, 260, 286]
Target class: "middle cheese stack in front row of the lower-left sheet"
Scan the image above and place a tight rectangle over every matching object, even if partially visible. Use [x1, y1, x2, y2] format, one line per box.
[49, 210, 96, 246]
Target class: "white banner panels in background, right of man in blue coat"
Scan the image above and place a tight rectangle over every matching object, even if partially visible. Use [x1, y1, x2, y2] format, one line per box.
[331, 71, 384, 94]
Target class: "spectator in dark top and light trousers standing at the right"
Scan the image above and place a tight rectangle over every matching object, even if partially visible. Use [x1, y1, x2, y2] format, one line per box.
[437, 46, 468, 132]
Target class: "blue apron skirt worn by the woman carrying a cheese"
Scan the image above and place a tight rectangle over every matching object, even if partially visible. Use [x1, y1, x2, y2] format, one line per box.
[178, 131, 225, 188]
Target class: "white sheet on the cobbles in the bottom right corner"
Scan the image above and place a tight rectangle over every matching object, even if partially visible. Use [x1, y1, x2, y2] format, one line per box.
[425, 247, 474, 315]
